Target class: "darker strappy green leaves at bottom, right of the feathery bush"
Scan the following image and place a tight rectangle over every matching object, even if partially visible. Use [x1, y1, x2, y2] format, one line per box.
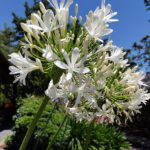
[69, 120, 130, 150]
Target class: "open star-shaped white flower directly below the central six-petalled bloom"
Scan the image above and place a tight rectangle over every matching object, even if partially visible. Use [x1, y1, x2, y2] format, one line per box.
[69, 78, 97, 104]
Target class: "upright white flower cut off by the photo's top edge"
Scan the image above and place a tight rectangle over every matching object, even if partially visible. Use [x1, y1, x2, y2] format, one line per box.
[51, 0, 73, 26]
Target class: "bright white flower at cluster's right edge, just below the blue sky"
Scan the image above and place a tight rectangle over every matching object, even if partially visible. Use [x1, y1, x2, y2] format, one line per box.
[108, 47, 128, 67]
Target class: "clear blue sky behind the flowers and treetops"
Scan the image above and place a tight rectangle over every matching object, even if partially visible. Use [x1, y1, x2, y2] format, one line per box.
[0, 0, 150, 48]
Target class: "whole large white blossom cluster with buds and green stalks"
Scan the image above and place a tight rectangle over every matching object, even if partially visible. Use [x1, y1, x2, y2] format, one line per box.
[9, 0, 150, 123]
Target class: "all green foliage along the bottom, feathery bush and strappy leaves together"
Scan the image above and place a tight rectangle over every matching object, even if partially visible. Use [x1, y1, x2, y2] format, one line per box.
[6, 96, 129, 150]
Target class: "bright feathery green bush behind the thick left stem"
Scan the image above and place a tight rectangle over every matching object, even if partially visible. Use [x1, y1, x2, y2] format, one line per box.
[7, 97, 69, 150]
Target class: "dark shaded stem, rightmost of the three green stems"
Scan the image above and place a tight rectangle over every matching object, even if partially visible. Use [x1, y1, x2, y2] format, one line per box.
[83, 118, 95, 150]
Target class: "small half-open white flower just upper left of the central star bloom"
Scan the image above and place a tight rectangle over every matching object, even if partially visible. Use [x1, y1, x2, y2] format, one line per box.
[42, 44, 59, 61]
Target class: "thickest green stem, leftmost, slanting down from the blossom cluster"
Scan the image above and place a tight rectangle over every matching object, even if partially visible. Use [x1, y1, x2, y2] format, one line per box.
[19, 97, 49, 150]
